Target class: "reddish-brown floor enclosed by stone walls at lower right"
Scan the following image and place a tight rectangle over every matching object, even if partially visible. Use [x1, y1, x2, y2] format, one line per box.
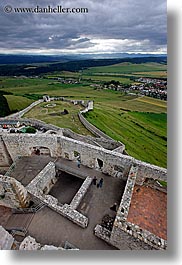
[127, 185, 167, 240]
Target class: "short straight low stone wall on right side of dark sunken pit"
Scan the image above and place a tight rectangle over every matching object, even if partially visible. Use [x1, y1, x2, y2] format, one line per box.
[70, 177, 92, 210]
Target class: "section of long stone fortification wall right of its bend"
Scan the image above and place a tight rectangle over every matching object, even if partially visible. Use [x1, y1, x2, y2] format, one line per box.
[58, 137, 167, 181]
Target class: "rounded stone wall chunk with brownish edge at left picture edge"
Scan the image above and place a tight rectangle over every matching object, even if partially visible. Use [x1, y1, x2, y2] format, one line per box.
[0, 176, 30, 208]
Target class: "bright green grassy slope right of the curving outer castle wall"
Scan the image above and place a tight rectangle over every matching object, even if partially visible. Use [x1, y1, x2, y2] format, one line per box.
[85, 99, 167, 167]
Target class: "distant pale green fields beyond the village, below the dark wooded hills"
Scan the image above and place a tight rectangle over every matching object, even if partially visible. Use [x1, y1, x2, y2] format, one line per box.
[46, 62, 167, 84]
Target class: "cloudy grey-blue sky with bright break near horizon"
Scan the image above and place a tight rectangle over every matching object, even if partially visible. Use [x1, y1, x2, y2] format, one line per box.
[0, 0, 167, 54]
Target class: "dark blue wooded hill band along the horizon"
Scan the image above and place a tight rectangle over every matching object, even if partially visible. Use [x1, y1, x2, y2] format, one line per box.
[0, 56, 167, 76]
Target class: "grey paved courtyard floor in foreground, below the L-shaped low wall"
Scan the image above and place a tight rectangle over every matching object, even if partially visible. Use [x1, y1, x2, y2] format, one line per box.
[28, 207, 115, 250]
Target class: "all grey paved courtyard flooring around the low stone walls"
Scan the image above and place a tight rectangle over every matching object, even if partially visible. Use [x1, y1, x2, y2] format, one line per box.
[0, 156, 155, 250]
